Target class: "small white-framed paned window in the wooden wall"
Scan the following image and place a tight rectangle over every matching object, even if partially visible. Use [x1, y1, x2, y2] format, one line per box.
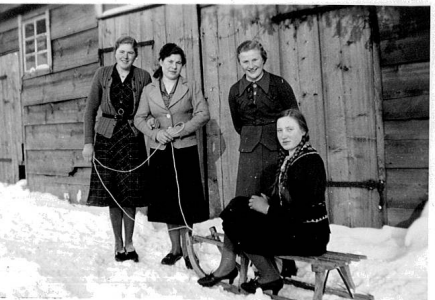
[18, 10, 53, 77]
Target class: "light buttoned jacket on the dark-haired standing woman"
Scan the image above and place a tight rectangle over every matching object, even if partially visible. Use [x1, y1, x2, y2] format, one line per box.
[134, 76, 210, 150]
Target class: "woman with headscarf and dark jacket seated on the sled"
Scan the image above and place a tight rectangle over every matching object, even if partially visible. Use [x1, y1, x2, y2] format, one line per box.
[198, 109, 330, 294]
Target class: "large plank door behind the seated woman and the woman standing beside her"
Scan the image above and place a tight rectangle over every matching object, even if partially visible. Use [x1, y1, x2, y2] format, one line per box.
[201, 5, 384, 227]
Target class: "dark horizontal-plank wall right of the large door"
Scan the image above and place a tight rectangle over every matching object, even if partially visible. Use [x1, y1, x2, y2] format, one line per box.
[377, 6, 430, 227]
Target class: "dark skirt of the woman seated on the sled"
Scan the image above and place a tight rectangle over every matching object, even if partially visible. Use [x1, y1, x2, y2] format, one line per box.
[220, 197, 329, 256]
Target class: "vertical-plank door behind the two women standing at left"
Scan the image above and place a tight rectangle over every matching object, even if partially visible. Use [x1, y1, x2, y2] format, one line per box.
[99, 5, 208, 203]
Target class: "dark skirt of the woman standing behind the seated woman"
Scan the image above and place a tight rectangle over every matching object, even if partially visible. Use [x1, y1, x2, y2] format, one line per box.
[236, 144, 278, 197]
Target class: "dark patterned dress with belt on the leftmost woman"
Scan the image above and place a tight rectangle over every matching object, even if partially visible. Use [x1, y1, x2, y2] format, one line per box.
[87, 68, 148, 207]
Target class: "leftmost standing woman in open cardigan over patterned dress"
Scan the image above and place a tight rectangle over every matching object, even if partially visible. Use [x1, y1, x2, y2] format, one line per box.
[83, 36, 151, 262]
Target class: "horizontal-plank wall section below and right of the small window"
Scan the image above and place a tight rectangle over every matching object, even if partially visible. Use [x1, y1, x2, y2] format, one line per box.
[21, 5, 99, 202]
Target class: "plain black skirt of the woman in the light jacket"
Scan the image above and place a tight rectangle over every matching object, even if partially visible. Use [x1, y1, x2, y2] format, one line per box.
[148, 144, 209, 226]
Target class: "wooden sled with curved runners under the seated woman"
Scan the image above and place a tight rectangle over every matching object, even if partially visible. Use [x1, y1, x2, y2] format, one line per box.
[183, 227, 374, 300]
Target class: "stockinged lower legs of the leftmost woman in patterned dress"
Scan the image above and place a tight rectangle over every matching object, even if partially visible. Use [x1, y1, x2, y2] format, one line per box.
[109, 207, 136, 252]
